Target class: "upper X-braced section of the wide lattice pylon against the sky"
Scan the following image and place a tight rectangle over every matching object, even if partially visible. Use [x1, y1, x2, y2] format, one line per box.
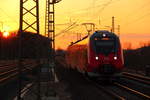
[19, 0, 39, 34]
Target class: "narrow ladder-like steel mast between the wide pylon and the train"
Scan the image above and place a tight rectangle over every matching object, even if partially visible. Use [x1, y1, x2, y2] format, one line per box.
[45, 0, 61, 80]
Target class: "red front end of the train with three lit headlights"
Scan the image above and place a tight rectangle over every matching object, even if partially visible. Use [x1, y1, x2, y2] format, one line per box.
[87, 31, 124, 75]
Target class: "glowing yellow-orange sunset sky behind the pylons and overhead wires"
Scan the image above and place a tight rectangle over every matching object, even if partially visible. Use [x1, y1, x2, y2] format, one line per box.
[0, 0, 150, 48]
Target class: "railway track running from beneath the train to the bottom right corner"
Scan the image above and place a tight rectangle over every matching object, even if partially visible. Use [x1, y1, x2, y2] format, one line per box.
[91, 79, 150, 100]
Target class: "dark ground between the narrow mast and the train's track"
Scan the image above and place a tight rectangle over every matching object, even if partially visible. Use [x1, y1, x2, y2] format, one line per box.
[56, 64, 112, 100]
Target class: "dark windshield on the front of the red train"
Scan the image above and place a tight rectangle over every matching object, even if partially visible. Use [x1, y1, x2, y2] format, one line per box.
[95, 40, 115, 55]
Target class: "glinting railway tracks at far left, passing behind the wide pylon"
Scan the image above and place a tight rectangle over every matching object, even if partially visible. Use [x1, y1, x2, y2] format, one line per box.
[0, 59, 41, 85]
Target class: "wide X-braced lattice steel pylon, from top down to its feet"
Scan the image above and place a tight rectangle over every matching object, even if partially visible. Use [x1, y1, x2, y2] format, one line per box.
[17, 0, 41, 100]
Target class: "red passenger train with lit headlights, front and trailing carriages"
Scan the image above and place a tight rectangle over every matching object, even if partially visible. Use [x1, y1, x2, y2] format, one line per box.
[66, 31, 124, 76]
